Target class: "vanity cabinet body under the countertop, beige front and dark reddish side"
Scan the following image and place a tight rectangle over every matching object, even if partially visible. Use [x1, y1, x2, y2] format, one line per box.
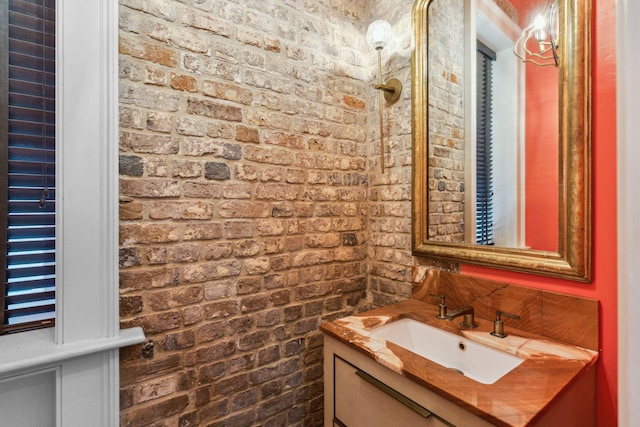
[324, 334, 596, 427]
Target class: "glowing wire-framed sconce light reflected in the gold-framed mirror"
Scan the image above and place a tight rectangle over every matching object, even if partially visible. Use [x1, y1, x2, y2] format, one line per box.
[513, 0, 559, 67]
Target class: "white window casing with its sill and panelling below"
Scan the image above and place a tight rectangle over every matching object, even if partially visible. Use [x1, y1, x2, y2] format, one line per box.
[0, 0, 144, 427]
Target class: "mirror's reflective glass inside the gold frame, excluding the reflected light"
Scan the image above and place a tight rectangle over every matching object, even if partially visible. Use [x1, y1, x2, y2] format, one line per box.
[428, 0, 558, 251]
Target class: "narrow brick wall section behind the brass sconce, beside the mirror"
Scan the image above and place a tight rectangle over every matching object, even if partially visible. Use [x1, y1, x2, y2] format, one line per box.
[367, 0, 458, 306]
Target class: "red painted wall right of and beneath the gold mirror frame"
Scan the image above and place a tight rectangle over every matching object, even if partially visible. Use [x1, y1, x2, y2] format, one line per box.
[462, 0, 618, 427]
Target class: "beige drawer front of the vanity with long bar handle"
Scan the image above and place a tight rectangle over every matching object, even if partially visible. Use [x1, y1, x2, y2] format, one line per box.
[324, 335, 492, 427]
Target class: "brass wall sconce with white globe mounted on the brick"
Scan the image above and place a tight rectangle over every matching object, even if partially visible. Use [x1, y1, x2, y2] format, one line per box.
[367, 20, 402, 173]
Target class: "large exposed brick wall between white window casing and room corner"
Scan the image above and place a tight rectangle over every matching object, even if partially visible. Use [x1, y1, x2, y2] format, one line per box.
[119, 0, 372, 427]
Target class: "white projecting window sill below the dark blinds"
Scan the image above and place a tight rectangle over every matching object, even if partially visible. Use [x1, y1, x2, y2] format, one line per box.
[0, 327, 145, 377]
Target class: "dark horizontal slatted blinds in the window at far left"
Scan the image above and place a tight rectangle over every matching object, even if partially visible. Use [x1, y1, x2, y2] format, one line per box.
[0, 0, 56, 332]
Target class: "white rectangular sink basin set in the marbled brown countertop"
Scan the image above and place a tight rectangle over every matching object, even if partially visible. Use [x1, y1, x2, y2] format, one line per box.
[370, 318, 524, 384]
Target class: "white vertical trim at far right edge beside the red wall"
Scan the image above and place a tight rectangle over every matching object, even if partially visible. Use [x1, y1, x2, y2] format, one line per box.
[616, 0, 640, 426]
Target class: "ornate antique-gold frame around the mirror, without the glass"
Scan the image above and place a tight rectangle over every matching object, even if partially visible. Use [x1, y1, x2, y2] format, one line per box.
[411, 0, 592, 282]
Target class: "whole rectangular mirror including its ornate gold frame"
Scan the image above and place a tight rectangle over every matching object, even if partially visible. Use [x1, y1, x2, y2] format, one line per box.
[412, 0, 591, 281]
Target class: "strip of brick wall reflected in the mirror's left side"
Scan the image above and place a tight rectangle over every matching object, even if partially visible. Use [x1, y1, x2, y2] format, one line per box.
[428, 0, 465, 242]
